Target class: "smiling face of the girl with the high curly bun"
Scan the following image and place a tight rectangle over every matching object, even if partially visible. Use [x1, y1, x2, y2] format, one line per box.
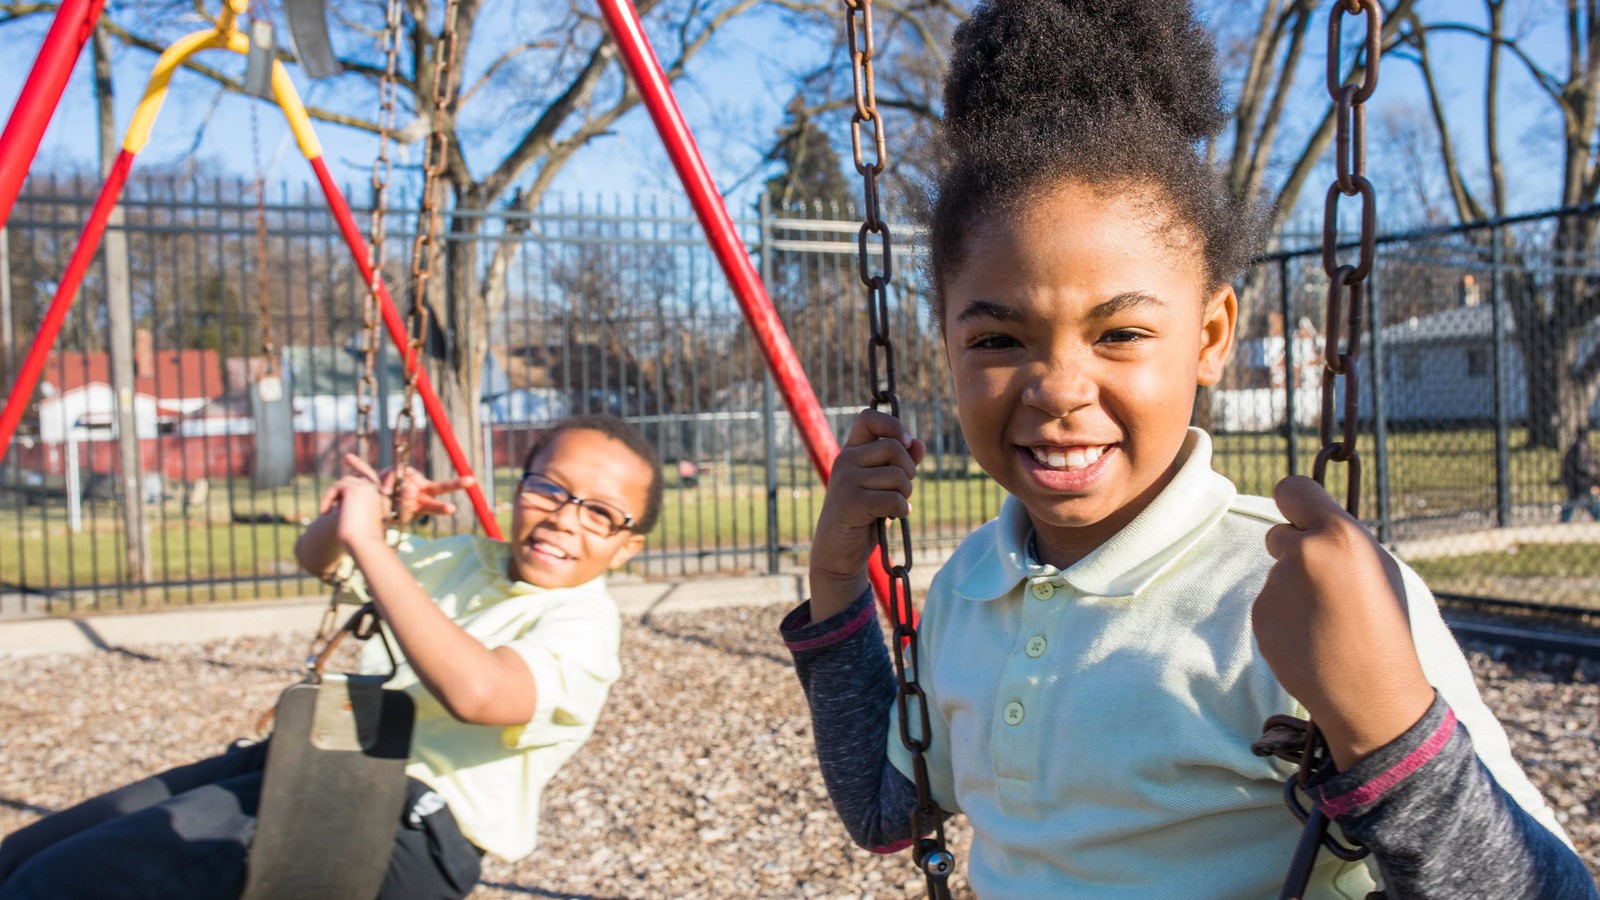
[944, 181, 1237, 565]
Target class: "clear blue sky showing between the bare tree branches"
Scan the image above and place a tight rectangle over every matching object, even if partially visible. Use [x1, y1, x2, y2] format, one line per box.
[0, 0, 1580, 218]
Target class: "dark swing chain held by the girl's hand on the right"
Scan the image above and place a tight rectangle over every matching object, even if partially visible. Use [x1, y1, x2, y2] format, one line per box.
[1258, 0, 1382, 900]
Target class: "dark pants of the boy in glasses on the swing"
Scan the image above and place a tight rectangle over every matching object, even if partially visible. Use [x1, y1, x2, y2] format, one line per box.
[0, 743, 482, 900]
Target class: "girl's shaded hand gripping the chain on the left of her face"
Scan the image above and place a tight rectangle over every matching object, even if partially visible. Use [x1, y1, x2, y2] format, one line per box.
[811, 410, 928, 621]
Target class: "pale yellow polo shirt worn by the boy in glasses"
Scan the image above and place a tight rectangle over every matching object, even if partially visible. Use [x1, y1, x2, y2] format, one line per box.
[350, 535, 622, 860]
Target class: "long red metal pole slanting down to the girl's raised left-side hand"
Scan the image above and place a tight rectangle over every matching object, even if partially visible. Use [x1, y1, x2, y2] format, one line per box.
[600, 0, 894, 608]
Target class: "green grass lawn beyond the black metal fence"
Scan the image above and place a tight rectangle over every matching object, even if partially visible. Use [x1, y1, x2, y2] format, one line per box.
[0, 429, 1600, 607]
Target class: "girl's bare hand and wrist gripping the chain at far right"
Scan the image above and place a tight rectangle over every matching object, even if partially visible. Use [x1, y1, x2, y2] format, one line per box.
[1251, 476, 1434, 770]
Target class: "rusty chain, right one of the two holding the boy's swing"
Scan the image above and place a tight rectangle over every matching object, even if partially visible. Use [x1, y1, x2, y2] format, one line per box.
[394, 0, 456, 490]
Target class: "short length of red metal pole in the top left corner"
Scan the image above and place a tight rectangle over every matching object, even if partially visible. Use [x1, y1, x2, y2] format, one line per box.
[0, 0, 106, 232]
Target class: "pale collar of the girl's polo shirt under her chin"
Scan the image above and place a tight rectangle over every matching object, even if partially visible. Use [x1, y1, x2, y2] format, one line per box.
[955, 428, 1237, 601]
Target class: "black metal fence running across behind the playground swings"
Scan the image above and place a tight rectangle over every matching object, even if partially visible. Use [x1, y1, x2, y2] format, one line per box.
[0, 179, 1600, 615]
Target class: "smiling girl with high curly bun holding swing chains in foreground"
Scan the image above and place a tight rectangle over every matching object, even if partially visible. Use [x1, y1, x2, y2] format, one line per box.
[782, 0, 1595, 900]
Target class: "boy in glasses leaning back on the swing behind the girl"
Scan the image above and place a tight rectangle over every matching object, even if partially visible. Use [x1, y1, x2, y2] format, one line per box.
[0, 416, 661, 900]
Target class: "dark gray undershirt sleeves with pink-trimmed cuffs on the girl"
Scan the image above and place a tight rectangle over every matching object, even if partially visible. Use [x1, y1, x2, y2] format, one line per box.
[781, 594, 1600, 900]
